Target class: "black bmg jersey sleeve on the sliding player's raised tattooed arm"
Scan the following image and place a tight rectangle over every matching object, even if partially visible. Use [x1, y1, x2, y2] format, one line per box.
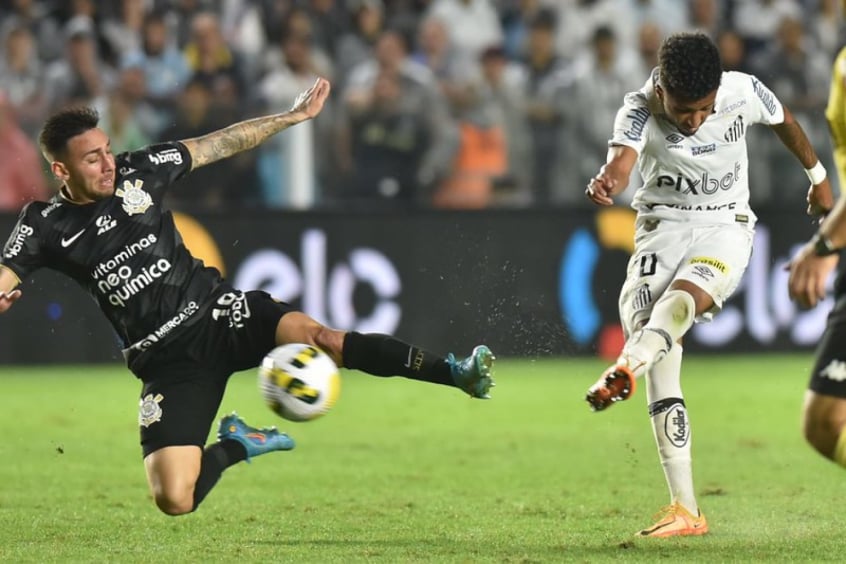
[116, 141, 192, 199]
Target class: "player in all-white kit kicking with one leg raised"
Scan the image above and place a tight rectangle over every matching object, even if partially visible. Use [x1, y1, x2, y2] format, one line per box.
[586, 33, 833, 537]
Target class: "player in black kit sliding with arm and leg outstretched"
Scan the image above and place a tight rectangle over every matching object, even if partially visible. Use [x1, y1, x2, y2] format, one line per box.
[0, 79, 493, 515]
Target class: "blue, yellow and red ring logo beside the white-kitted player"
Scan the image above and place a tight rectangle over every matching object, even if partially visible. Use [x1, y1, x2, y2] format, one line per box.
[558, 207, 635, 357]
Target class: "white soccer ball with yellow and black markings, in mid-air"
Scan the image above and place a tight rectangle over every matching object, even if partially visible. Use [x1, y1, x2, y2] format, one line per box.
[259, 343, 341, 421]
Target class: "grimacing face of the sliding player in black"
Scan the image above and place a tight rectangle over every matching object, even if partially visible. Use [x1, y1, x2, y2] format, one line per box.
[52, 128, 115, 204]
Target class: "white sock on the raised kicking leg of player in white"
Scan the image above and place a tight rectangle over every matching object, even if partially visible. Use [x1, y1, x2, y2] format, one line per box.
[617, 290, 696, 378]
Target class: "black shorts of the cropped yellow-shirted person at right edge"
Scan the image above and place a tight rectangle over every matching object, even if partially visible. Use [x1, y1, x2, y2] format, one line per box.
[808, 297, 846, 398]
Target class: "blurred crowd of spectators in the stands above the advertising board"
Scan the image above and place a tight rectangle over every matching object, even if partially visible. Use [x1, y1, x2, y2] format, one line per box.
[0, 0, 844, 210]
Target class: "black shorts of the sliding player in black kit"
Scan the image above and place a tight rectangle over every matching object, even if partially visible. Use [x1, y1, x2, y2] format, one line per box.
[136, 289, 295, 457]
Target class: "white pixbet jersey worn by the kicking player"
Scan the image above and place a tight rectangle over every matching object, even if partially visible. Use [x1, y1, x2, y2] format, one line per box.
[609, 69, 784, 223]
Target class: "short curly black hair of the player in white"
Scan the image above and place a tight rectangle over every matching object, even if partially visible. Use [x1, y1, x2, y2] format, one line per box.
[658, 33, 723, 101]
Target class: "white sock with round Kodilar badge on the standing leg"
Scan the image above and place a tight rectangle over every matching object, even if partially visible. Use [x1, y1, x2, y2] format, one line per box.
[646, 344, 699, 515]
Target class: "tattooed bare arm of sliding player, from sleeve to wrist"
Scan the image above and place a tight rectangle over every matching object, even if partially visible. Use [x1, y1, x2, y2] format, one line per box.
[182, 112, 307, 169]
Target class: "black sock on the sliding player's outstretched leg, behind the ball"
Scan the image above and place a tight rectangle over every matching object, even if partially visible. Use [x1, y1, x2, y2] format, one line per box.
[343, 331, 455, 386]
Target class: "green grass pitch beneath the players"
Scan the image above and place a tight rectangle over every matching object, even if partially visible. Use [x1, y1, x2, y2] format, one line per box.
[0, 354, 846, 563]
